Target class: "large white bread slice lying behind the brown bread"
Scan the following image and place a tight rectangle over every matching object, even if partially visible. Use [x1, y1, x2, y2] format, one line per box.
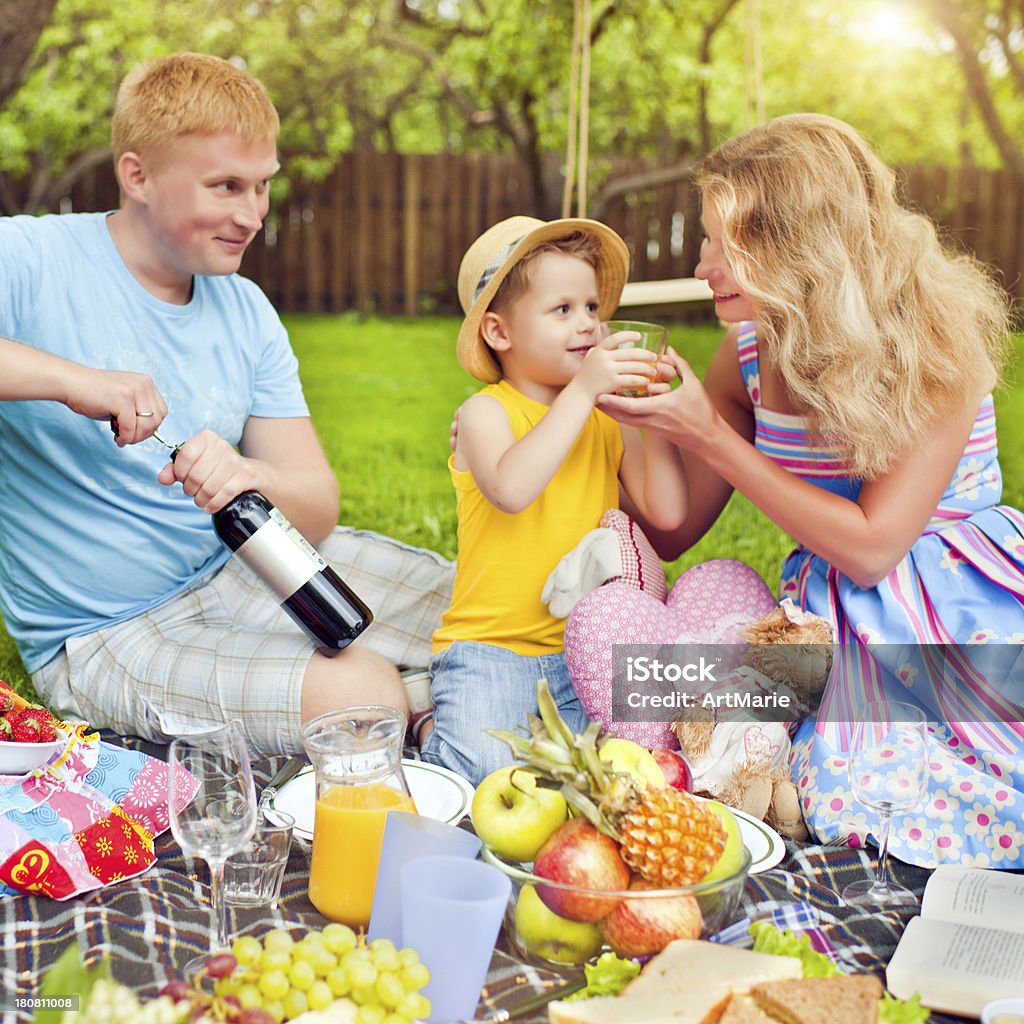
[624, 939, 803, 995]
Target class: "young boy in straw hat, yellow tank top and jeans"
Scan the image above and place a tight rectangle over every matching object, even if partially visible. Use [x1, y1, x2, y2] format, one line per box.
[423, 217, 686, 783]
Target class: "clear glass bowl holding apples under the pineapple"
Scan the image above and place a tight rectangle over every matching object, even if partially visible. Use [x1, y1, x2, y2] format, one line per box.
[481, 845, 751, 970]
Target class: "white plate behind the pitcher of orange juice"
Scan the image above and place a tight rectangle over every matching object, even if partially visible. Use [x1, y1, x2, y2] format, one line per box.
[265, 758, 475, 840]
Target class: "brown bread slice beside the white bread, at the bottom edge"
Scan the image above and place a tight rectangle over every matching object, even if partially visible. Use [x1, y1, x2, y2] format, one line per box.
[751, 974, 882, 1024]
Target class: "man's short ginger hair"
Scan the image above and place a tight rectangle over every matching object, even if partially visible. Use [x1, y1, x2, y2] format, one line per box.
[111, 53, 281, 163]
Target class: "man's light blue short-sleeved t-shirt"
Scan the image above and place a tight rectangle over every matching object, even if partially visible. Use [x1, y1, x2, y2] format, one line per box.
[0, 213, 308, 672]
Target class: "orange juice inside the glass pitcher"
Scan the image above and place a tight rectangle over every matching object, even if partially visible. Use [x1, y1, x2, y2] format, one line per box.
[309, 783, 416, 929]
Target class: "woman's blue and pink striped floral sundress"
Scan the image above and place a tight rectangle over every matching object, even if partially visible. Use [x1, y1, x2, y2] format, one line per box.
[739, 324, 1024, 869]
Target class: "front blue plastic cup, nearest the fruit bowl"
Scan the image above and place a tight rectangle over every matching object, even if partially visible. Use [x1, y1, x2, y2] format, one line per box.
[401, 856, 512, 1021]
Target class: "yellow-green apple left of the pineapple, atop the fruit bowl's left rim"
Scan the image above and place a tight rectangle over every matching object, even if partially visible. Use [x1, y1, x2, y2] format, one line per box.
[473, 765, 568, 861]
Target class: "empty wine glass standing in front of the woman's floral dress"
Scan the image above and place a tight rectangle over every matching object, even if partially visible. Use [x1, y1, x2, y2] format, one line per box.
[843, 700, 928, 906]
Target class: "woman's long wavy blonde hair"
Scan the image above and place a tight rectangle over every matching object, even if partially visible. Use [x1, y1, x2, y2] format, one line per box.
[697, 114, 1010, 479]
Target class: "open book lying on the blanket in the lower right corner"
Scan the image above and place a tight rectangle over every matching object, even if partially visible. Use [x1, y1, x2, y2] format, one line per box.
[886, 864, 1024, 1017]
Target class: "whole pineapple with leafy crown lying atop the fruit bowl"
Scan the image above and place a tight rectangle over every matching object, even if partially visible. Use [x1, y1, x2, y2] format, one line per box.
[489, 679, 726, 888]
